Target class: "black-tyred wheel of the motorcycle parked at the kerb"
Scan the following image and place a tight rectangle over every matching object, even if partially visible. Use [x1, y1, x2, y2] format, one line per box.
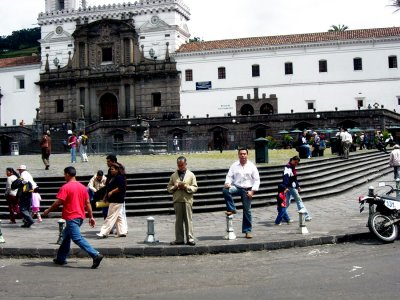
[368, 212, 398, 243]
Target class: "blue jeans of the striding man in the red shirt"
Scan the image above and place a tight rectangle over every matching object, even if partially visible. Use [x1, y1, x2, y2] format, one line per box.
[57, 219, 99, 262]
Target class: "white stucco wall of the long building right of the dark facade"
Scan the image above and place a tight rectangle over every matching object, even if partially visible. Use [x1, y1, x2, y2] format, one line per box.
[175, 37, 400, 117]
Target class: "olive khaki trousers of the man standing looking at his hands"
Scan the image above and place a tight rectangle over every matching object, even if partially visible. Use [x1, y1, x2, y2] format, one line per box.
[174, 202, 194, 243]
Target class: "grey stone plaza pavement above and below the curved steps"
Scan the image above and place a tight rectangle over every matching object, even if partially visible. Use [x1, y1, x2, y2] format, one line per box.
[0, 154, 392, 257]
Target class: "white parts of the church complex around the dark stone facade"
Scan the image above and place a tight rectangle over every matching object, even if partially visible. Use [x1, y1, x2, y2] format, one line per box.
[0, 0, 400, 126]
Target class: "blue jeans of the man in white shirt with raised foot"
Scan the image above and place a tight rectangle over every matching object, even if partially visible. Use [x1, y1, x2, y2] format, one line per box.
[222, 185, 252, 233]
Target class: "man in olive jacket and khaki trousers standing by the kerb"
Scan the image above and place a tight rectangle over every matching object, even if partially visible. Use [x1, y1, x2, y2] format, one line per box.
[167, 156, 197, 246]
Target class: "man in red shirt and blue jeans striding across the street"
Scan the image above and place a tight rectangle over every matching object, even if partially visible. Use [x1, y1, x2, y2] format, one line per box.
[43, 167, 103, 269]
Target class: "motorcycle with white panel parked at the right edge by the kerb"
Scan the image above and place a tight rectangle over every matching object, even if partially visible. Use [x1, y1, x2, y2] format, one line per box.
[358, 183, 400, 243]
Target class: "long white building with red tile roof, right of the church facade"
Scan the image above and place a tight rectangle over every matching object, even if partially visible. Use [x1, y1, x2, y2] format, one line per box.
[175, 27, 400, 117]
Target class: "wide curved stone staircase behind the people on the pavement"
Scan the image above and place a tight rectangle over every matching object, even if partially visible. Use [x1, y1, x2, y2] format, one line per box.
[0, 151, 392, 218]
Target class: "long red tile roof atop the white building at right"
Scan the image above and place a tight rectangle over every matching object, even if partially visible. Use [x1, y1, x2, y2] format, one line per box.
[177, 27, 400, 53]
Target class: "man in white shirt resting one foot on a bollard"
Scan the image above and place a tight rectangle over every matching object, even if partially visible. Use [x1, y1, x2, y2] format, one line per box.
[222, 148, 260, 239]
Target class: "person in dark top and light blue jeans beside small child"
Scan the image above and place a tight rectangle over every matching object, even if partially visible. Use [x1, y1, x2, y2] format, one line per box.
[282, 156, 312, 221]
